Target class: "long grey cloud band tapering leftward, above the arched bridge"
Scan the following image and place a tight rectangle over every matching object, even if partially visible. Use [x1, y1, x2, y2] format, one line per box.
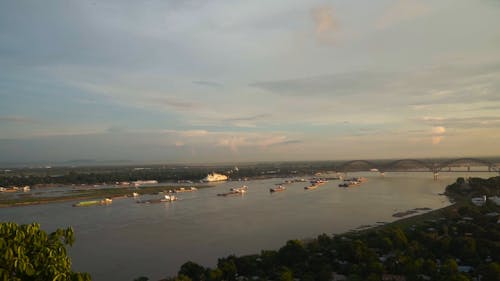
[250, 61, 500, 110]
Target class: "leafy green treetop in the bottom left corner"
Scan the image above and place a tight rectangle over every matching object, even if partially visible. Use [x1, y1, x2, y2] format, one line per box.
[0, 222, 91, 281]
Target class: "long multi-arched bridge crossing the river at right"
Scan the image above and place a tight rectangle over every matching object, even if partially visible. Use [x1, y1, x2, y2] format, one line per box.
[335, 158, 500, 179]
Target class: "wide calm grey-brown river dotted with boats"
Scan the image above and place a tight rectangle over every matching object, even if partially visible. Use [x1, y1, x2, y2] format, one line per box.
[0, 172, 495, 281]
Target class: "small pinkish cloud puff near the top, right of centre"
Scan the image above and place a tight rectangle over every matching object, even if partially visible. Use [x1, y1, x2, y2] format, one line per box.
[311, 6, 339, 44]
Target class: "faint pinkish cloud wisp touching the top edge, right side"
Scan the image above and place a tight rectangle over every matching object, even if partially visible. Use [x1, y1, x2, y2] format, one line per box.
[376, 0, 431, 29]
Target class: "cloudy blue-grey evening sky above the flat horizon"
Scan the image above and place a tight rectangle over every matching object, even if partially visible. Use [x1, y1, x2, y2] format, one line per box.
[0, 0, 500, 163]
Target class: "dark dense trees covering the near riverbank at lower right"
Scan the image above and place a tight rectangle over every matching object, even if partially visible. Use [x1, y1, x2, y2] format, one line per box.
[142, 177, 500, 281]
